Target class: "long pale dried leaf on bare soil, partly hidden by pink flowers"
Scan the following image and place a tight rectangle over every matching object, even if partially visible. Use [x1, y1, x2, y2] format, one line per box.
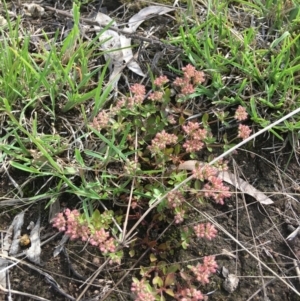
[178, 160, 274, 205]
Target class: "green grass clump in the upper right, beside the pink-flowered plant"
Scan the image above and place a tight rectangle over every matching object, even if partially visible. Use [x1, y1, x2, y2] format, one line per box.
[172, 1, 300, 140]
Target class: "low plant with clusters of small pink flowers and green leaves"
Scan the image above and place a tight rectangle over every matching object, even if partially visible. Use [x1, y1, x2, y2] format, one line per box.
[53, 65, 251, 301]
